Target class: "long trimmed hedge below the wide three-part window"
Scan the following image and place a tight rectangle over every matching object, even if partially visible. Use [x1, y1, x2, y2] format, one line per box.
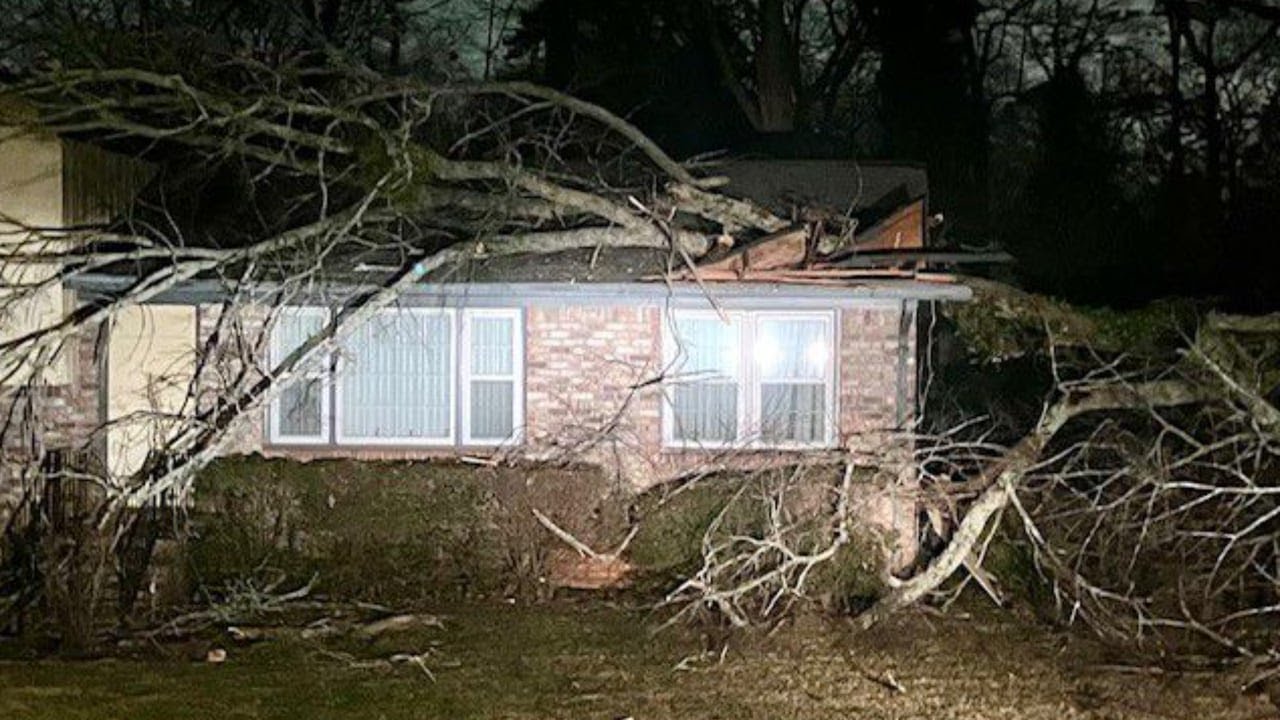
[187, 456, 621, 602]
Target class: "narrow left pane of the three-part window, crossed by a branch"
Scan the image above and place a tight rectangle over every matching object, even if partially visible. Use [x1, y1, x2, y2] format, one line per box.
[271, 309, 328, 438]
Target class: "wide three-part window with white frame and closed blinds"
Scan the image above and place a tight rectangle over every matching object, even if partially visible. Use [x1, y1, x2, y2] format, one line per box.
[269, 307, 524, 446]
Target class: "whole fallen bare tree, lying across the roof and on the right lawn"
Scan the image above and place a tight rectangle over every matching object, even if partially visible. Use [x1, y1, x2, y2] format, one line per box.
[0, 23, 1280, 676]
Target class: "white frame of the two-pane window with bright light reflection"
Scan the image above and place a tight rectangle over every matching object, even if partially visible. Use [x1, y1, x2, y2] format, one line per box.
[662, 309, 840, 450]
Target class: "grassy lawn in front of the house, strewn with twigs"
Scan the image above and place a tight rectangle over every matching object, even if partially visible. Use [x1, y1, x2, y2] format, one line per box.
[0, 602, 1275, 720]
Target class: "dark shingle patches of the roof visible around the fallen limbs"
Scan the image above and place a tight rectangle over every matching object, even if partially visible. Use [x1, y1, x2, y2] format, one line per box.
[90, 159, 927, 283]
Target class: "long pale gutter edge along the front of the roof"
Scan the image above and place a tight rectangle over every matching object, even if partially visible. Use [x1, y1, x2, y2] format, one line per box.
[67, 274, 973, 307]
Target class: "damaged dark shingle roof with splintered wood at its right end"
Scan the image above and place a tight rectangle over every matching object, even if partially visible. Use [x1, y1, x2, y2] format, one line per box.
[70, 159, 968, 300]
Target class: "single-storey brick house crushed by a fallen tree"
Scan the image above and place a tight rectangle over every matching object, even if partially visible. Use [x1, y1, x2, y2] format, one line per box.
[0, 124, 969, 561]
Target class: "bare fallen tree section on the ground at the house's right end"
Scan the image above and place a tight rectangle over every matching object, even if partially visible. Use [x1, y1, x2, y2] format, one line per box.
[680, 278, 1280, 678]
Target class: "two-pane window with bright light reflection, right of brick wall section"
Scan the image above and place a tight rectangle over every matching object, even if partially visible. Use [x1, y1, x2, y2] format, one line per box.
[663, 310, 835, 447]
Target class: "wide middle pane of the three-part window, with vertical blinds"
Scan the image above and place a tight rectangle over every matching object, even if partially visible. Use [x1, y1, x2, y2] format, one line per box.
[339, 310, 453, 439]
